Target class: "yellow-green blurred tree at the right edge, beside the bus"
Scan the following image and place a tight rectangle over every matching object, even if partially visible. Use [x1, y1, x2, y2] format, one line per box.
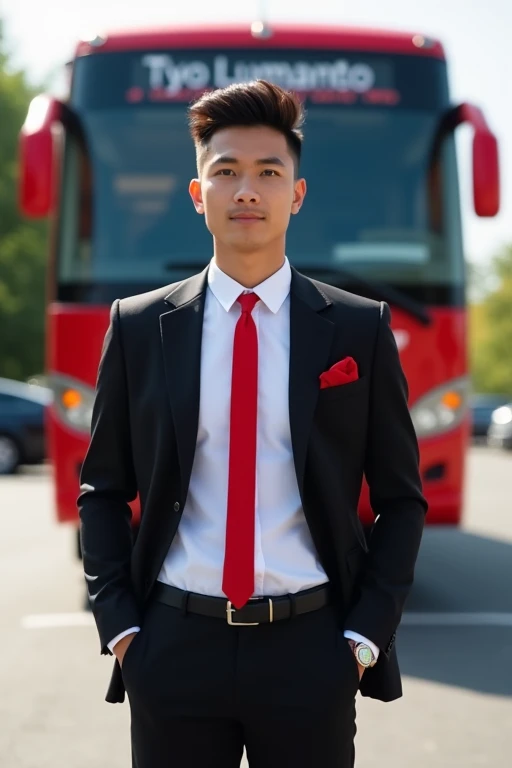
[470, 245, 512, 398]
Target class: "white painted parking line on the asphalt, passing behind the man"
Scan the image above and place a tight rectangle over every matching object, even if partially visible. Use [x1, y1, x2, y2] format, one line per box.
[21, 611, 512, 629]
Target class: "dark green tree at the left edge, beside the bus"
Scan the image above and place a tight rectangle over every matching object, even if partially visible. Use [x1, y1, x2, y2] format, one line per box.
[0, 23, 46, 379]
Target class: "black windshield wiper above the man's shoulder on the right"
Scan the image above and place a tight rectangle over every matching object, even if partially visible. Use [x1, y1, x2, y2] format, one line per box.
[298, 265, 432, 325]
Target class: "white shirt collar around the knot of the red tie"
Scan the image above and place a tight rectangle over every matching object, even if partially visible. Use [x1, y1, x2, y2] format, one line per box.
[208, 256, 292, 314]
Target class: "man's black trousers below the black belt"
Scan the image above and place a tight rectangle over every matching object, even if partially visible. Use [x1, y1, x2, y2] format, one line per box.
[122, 602, 359, 768]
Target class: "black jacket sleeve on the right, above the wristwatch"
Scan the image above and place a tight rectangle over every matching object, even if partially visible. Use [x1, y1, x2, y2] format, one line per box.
[345, 302, 427, 656]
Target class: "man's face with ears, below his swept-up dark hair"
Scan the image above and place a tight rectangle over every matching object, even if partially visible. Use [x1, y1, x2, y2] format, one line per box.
[190, 126, 306, 253]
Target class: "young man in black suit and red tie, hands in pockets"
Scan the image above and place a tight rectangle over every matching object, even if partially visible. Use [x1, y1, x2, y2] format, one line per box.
[79, 81, 427, 768]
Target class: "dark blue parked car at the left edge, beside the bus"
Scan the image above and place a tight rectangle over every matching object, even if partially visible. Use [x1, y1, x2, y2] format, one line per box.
[0, 378, 53, 475]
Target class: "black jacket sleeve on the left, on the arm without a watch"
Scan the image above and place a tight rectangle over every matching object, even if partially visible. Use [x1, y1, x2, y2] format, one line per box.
[78, 300, 141, 654]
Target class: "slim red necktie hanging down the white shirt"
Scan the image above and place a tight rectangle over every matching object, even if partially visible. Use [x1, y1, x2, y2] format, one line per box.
[222, 293, 259, 608]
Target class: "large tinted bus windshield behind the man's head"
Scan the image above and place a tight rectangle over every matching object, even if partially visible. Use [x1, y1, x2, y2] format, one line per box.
[58, 47, 464, 304]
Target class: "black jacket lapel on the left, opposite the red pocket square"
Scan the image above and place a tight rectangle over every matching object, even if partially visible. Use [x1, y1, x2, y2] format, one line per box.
[160, 268, 208, 498]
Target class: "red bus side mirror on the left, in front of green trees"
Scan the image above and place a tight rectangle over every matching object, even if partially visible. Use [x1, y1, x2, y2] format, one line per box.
[18, 94, 63, 218]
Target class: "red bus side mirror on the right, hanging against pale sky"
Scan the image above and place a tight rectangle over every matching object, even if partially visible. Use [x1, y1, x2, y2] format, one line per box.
[452, 104, 500, 216]
